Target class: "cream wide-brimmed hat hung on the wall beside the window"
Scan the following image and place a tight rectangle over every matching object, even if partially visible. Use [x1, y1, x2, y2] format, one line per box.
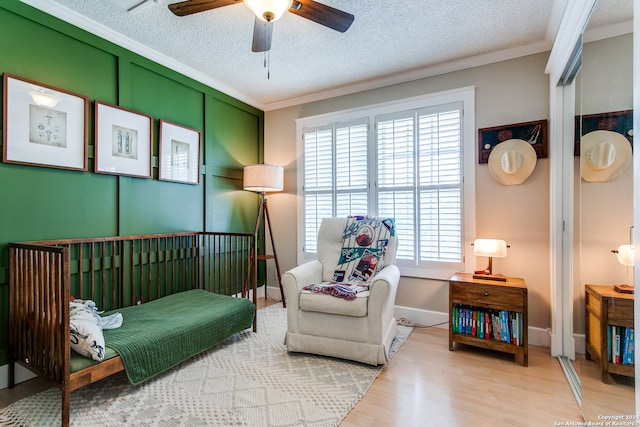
[489, 139, 538, 185]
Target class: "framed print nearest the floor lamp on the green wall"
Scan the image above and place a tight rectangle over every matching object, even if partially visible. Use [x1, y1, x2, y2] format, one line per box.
[158, 120, 200, 184]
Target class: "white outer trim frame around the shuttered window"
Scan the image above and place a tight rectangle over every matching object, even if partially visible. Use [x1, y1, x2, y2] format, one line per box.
[296, 86, 477, 280]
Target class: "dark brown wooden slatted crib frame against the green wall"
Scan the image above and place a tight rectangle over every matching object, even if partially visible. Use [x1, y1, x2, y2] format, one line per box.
[9, 232, 257, 426]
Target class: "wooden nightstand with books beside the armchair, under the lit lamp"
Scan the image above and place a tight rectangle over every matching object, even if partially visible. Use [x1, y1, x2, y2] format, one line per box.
[449, 273, 529, 366]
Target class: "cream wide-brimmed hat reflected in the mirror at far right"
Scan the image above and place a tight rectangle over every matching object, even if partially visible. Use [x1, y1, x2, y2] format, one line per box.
[580, 130, 632, 182]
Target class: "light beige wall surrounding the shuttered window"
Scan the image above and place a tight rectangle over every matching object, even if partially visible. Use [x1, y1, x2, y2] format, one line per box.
[265, 54, 551, 329]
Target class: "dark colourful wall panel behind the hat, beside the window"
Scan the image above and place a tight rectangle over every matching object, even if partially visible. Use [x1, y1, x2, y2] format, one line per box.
[478, 119, 547, 164]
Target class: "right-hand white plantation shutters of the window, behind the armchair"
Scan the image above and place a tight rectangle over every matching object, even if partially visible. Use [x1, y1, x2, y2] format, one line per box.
[376, 104, 463, 267]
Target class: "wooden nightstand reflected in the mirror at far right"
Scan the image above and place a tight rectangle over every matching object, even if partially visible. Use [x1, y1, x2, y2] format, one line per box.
[584, 285, 635, 383]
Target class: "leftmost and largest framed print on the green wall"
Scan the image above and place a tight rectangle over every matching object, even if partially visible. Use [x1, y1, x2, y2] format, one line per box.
[2, 73, 89, 171]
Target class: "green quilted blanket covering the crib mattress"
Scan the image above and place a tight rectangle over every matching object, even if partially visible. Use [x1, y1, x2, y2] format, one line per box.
[99, 289, 255, 384]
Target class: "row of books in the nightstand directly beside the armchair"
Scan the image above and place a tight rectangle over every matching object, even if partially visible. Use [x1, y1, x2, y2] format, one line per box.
[451, 304, 523, 345]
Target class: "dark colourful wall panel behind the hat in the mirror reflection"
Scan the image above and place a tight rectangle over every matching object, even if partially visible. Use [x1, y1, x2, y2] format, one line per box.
[573, 110, 633, 156]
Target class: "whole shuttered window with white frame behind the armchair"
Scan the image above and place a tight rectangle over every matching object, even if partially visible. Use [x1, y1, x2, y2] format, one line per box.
[298, 88, 475, 278]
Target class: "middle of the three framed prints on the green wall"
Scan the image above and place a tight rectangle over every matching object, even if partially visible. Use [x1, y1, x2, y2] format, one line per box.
[94, 101, 153, 178]
